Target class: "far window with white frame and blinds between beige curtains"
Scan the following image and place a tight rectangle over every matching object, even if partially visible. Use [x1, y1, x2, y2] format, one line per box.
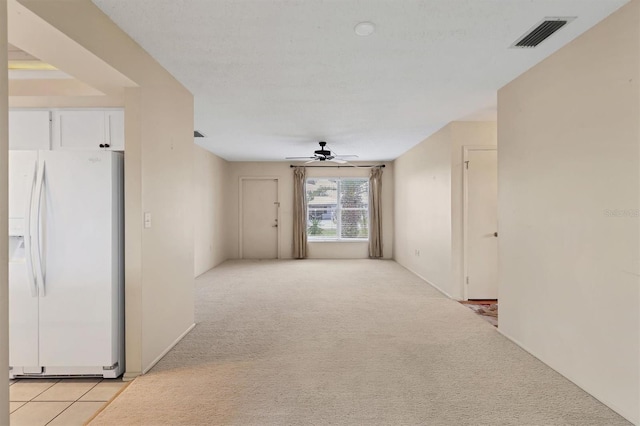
[306, 178, 369, 241]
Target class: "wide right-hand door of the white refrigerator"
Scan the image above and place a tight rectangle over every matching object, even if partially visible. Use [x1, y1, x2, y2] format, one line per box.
[39, 151, 118, 369]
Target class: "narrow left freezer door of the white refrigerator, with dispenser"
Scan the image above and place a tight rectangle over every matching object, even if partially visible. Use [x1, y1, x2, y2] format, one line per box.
[9, 151, 40, 367]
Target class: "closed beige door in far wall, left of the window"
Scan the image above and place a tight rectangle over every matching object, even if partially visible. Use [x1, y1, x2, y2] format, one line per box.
[241, 179, 278, 259]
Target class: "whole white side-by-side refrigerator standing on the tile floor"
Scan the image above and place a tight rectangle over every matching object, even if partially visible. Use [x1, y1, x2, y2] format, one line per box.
[9, 151, 124, 378]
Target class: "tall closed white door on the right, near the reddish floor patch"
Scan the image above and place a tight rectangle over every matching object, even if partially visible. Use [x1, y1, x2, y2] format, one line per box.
[465, 149, 498, 299]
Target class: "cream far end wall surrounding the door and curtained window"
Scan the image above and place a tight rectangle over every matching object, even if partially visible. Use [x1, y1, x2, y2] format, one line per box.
[225, 162, 394, 259]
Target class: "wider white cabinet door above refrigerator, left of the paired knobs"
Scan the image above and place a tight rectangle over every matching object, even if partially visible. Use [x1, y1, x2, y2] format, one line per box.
[53, 110, 106, 149]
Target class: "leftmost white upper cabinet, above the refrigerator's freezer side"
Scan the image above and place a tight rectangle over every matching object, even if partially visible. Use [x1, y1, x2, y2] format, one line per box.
[9, 110, 51, 150]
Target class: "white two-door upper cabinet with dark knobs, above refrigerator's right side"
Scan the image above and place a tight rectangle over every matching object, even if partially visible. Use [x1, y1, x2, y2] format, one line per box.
[52, 110, 124, 151]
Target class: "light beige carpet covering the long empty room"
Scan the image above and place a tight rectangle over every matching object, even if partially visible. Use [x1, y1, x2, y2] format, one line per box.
[91, 260, 629, 426]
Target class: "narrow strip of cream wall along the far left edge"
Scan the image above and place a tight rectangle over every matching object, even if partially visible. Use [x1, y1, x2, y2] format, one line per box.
[0, 0, 9, 425]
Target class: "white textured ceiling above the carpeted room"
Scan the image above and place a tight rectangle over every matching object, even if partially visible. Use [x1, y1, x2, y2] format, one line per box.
[93, 0, 626, 161]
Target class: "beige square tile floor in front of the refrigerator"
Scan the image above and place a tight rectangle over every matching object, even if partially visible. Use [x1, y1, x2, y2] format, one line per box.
[9, 378, 127, 426]
